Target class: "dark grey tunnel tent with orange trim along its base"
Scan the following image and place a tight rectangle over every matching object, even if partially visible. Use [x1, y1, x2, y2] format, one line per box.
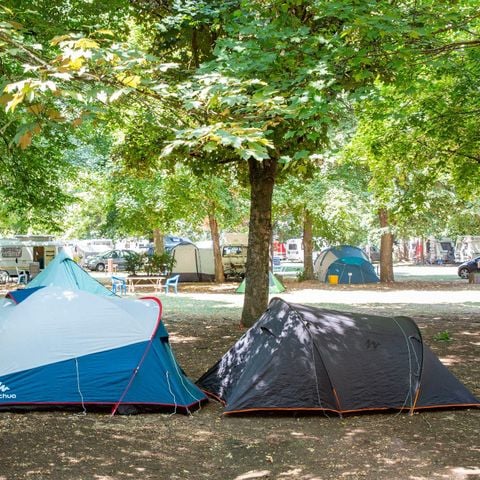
[197, 298, 480, 414]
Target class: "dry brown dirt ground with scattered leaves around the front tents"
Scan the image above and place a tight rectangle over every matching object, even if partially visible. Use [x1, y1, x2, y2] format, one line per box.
[0, 283, 480, 480]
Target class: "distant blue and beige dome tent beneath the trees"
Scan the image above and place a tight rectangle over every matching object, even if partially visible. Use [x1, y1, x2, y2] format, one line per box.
[314, 245, 379, 284]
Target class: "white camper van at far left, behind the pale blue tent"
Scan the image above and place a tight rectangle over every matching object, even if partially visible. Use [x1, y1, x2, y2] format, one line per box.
[0, 235, 62, 276]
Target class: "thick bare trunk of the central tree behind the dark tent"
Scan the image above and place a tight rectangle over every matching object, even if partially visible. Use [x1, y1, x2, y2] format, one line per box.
[241, 158, 277, 327]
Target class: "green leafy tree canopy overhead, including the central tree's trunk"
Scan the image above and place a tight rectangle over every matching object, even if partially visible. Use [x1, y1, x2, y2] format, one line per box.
[0, 0, 480, 325]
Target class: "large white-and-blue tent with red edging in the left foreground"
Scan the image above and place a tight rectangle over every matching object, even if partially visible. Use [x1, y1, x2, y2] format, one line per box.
[0, 287, 206, 412]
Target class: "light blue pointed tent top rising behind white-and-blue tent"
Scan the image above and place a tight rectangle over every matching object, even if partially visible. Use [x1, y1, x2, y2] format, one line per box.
[27, 251, 115, 297]
